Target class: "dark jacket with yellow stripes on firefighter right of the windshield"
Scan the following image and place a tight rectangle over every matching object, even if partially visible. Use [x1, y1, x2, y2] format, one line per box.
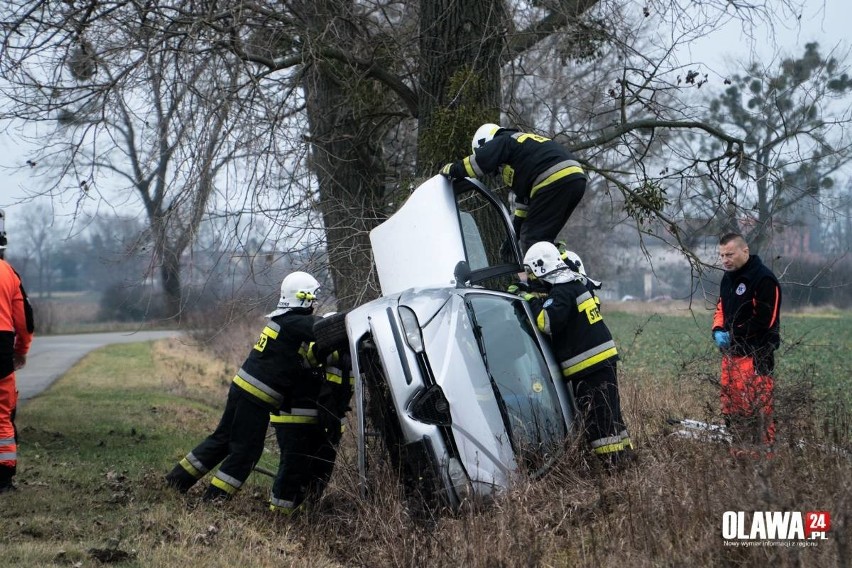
[530, 280, 618, 379]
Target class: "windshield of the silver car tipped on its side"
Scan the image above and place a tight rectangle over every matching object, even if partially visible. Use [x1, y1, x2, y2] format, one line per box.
[466, 294, 566, 472]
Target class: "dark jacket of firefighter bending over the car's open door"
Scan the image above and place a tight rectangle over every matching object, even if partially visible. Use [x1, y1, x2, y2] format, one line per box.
[450, 130, 586, 203]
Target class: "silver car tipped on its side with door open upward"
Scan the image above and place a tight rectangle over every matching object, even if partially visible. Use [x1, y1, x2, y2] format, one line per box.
[320, 176, 574, 508]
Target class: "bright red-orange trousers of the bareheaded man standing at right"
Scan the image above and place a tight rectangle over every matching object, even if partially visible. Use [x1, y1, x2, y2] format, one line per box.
[721, 355, 775, 444]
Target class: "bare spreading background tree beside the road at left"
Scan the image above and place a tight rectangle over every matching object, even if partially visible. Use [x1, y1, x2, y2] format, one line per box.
[4, 2, 312, 316]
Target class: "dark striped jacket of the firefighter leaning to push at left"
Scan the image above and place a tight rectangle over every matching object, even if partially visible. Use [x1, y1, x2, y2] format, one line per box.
[234, 308, 319, 409]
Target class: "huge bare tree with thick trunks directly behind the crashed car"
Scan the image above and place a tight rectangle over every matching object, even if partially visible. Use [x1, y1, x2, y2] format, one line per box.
[0, 0, 824, 308]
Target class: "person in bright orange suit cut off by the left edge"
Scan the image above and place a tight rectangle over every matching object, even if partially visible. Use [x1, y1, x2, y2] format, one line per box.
[0, 216, 34, 493]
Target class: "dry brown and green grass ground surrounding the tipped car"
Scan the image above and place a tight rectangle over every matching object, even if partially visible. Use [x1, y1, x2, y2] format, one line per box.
[0, 308, 852, 567]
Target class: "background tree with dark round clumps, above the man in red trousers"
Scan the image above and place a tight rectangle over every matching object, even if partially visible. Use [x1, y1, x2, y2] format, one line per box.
[688, 43, 852, 251]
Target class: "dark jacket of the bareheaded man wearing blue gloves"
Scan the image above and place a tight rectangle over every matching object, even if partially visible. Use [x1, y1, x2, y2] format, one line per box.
[713, 255, 781, 356]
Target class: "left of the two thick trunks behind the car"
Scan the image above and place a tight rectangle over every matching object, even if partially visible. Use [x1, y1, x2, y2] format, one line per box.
[296, 0, 386, 310]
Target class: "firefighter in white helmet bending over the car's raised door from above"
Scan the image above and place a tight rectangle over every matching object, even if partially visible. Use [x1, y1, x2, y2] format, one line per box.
[441, 124, 586, 255]
